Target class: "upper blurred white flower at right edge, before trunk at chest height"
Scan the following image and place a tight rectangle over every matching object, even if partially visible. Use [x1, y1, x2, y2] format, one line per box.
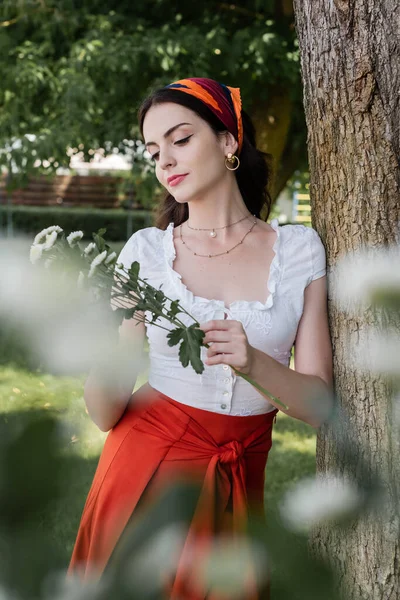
[331, 246, 400, 313]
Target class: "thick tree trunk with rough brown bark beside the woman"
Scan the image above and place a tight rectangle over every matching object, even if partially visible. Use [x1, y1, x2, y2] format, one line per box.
[294, 0, 400, 600]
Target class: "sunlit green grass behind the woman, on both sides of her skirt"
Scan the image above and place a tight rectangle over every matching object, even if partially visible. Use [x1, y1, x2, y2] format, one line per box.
[0, 365, 316, 564]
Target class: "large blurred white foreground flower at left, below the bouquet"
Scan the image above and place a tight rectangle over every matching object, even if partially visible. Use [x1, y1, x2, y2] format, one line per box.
[0, 232, 142, 385]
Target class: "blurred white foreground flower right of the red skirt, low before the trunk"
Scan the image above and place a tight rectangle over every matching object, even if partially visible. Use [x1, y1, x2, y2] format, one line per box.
[280, 474, 364, 533]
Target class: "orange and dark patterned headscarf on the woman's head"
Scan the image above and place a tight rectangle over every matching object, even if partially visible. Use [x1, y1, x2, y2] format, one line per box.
[165, 77, 243, 154]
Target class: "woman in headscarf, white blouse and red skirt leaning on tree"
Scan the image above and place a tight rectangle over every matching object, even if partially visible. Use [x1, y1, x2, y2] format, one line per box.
[70, 78, 332, 600]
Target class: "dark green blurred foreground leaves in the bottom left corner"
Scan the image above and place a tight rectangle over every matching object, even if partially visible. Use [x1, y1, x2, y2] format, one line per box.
[0, 409, 69, 599]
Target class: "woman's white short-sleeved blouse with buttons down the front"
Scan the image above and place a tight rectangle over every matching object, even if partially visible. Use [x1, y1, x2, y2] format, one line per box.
[117, 219, 326, 416]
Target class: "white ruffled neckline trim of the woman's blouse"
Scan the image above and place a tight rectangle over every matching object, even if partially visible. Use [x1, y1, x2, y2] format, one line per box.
[163, 218, 282, 313]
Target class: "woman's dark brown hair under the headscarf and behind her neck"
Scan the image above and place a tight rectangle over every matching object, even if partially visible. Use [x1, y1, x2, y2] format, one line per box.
[138, 88, 272, 229]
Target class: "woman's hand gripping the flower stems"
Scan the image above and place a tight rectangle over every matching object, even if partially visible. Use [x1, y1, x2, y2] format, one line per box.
[199, 319, 254, 375]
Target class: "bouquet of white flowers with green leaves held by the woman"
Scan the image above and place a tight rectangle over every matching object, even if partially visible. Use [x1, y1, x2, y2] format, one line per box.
[30, 225, 288, 409]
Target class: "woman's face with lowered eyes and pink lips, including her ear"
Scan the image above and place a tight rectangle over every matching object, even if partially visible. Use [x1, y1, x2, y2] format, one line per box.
[143, 102, 237, 202]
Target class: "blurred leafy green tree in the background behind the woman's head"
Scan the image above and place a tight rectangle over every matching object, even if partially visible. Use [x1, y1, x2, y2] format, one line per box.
[0, 0, 306, 198]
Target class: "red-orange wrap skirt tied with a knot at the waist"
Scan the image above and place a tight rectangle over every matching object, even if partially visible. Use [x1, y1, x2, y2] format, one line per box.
[68, 383, 278, 600]
